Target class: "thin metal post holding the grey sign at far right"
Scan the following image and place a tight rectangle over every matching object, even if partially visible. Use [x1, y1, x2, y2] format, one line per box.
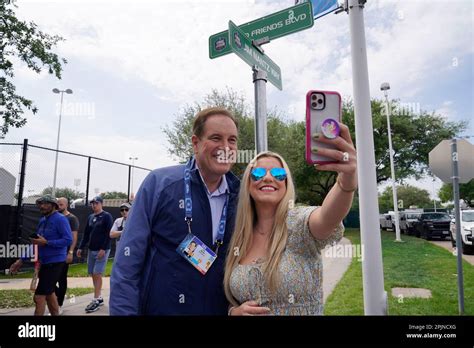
[451, 139, 464, 315]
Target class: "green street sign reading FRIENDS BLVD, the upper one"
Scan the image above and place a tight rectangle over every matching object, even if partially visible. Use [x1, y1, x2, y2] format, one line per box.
[209, 2, 314, 59]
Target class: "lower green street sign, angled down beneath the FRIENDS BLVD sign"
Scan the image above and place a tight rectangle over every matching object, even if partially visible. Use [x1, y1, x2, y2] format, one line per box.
[228, 21, 283, 90]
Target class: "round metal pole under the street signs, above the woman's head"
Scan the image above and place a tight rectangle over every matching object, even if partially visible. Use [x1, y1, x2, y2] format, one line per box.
[252, 66, 268, 154]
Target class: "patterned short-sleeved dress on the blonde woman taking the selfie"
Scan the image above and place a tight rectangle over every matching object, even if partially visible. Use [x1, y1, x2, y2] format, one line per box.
[230, 207, 344, 315]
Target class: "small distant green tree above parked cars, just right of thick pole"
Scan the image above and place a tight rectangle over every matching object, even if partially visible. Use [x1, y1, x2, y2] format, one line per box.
[379, 185, 432, 213]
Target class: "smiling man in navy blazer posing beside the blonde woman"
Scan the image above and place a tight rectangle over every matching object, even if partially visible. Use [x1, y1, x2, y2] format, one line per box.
[109, 108, 240, 315]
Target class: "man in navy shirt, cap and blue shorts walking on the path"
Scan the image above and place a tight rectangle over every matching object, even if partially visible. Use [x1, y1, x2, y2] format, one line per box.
[76, 196, 113, 313]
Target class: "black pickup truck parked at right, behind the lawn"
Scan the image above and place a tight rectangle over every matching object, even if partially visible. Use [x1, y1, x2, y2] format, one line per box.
[413, 213, 451, 240]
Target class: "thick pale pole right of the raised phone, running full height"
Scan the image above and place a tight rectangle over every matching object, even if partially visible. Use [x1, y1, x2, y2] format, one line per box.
[346, 0, 387, 315]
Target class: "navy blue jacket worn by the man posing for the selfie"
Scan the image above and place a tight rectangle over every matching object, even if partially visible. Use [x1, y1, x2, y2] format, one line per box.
[109, 159, 240, 315]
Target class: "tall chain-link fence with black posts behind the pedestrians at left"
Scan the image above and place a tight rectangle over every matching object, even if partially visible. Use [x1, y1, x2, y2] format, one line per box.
[0, 139, 150, 247]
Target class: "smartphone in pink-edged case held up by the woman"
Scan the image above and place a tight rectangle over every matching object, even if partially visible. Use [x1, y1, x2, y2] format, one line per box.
[306, 90, 342, 165]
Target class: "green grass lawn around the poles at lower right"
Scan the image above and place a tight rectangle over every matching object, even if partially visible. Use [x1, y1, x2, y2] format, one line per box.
[324, 229, 474, 315]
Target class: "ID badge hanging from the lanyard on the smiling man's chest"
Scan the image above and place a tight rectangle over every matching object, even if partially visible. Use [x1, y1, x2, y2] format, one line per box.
[176, 233, 217, 275]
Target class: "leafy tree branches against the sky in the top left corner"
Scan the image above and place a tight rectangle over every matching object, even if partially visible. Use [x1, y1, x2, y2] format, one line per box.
[0, 0, 67, 137]
